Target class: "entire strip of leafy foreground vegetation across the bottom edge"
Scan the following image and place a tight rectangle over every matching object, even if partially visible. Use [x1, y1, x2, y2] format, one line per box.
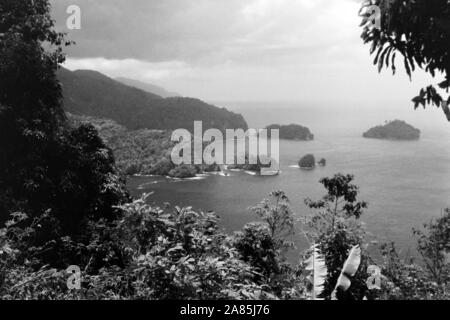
[0, 175, 450, 300]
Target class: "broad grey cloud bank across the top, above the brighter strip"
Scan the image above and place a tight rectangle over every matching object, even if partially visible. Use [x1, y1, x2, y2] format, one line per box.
[52, 0, 358, 64]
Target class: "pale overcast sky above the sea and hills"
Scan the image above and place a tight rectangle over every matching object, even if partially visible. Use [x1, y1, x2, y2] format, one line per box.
[51, 0, 436, 102]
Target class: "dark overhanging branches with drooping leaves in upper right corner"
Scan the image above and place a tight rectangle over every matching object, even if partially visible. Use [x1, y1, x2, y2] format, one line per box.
[361, 0, 450, 121]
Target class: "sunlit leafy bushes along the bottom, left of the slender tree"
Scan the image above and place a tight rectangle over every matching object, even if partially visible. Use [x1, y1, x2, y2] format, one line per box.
[0, 192, 302, 299]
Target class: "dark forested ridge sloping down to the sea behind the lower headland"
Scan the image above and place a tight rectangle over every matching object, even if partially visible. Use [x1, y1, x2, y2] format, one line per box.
[58, 68, 248, 131]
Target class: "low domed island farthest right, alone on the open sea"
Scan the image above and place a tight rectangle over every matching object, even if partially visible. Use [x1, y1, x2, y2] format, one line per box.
[363, 120, 420, 140]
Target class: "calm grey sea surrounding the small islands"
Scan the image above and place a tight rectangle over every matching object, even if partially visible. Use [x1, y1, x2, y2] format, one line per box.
[128, 101, 450, 262]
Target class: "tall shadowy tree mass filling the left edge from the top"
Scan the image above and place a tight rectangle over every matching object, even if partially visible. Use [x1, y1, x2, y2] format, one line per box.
[0, 0, 126, 235]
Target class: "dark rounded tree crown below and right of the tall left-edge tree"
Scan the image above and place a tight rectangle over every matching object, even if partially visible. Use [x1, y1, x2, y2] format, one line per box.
[48, 125, 129, 235]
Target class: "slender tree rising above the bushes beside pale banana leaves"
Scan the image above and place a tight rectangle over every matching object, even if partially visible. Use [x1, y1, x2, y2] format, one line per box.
[305, 174, 367, 299]
